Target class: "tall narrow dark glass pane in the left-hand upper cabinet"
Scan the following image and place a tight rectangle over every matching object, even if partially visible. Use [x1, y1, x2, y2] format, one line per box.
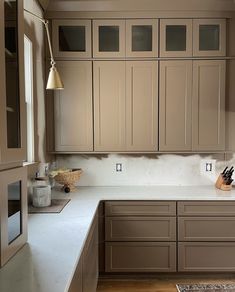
[4, 0, 21, 148]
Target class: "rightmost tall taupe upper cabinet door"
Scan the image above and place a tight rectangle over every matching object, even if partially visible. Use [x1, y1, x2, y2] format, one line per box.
[193, 60, 225, 151]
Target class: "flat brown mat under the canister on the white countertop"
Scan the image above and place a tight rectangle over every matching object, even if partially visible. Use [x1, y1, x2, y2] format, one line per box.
[28, 199, 70, 214]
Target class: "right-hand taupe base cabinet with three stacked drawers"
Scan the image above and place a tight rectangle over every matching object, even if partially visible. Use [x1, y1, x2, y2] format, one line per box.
[178, 201, 235, 272]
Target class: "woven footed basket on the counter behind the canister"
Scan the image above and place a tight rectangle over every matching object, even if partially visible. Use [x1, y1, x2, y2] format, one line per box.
[54, 169, 82, 192]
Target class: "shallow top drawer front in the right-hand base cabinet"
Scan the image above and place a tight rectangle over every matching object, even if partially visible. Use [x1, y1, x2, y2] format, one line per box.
[178, 201, 235, 216]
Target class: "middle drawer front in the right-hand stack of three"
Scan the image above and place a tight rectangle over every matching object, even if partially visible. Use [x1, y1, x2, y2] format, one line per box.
[178, 217, 235, 241]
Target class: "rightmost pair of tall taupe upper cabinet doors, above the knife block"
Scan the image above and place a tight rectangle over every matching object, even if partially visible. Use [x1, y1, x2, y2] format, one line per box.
[159, 60, 226, 151]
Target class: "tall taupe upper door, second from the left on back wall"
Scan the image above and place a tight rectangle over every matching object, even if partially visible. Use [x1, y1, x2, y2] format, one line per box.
[94, 61, 126, 151]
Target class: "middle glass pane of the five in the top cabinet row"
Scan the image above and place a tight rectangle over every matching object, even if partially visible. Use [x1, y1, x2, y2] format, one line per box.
[132, 25, 152, 52]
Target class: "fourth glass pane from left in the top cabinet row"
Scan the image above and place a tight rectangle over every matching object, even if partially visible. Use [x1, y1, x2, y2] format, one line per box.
[166, 25, 187, 51]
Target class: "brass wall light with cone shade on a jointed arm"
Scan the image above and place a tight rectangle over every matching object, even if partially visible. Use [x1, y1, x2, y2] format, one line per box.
[24, 9, 64, 90]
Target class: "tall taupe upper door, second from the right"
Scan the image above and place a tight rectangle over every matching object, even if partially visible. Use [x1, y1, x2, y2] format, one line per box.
[159, 61, 192, 151]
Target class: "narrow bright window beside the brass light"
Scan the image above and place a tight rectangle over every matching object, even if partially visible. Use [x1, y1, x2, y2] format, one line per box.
[24, 36, 34, 162]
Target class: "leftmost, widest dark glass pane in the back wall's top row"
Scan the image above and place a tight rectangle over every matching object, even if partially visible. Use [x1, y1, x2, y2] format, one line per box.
[59, 26, 86, 52]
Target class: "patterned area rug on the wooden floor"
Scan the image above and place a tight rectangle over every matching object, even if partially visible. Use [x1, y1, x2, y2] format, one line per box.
[176, 284, 235, 292]
